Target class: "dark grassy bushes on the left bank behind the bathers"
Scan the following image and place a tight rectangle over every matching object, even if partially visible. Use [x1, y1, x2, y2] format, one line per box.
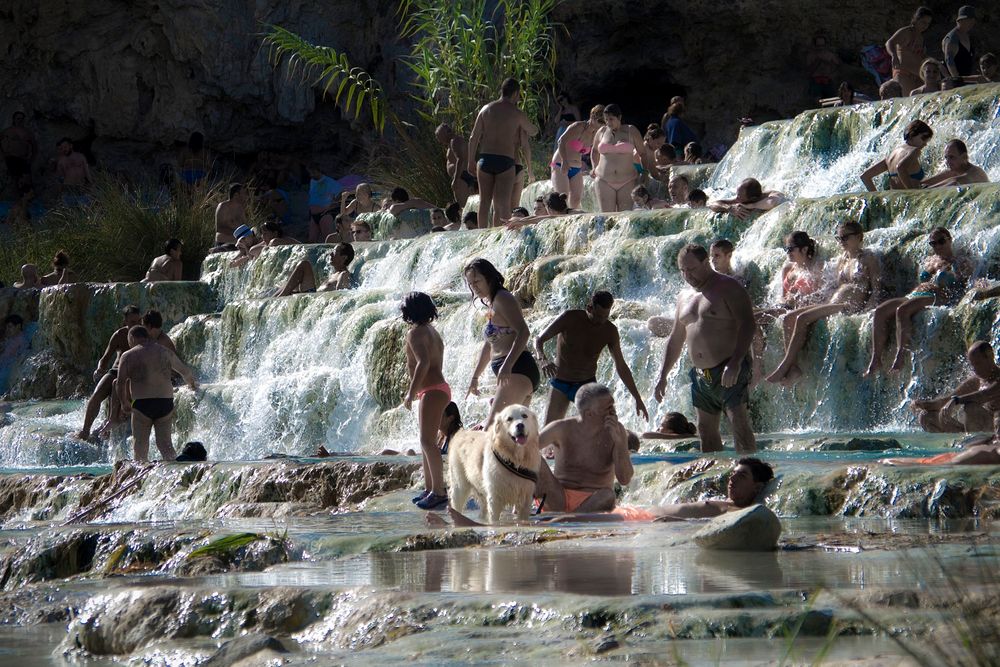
[0, 173, 246, 282]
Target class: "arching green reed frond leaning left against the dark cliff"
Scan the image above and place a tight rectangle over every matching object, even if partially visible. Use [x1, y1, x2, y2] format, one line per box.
[264, 25, 386, 132]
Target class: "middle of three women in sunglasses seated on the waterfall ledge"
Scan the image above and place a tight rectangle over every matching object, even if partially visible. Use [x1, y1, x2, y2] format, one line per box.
[767, 222, 882, 384]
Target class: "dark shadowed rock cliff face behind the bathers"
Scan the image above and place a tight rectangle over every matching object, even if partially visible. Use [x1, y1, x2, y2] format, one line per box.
[0, 0, 998, 169]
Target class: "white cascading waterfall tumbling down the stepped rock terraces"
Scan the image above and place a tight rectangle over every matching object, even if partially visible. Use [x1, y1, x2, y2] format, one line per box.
[0, 86, 1000, 465]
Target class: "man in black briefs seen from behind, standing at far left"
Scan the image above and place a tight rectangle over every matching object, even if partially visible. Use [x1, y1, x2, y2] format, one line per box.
[118, 327, 198, 462]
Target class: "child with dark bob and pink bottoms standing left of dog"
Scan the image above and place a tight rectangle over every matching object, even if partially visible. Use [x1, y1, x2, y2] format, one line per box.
[399, 292, 451, 510]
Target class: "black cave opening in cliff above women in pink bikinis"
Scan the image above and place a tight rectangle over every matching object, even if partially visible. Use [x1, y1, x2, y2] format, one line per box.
[570, 67, 690, 133]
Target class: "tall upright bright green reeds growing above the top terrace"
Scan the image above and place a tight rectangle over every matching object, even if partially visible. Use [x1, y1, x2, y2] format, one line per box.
[400, 0, 558, 135]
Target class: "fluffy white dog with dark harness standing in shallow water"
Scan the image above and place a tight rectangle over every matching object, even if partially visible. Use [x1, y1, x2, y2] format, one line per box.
[448, 405, 542, 523]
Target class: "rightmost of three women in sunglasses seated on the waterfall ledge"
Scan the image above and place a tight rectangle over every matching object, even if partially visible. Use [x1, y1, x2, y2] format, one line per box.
[864, 227, 973, 376]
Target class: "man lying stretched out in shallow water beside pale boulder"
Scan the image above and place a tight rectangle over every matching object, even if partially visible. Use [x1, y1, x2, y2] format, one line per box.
[427, 457, 774, 526]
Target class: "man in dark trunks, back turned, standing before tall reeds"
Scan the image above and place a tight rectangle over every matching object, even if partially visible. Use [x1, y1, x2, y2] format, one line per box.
[468, 79, 538, 227]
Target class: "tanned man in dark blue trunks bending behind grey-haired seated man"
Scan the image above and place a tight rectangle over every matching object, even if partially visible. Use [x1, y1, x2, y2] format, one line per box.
[535, 291, 649, 424]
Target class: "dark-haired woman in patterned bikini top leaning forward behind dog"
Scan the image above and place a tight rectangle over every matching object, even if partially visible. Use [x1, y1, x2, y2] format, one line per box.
[462, 257, 541, 428]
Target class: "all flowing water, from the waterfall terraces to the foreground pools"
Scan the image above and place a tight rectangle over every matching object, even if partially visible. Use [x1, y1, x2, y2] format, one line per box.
[0, 86, 1000, 664]
